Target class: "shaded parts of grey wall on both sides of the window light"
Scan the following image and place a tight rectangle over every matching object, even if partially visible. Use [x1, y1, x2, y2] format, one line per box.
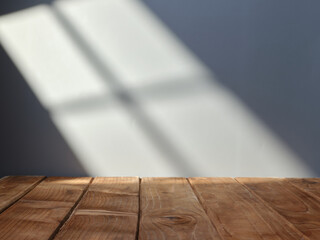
[0, 0, 320, 176]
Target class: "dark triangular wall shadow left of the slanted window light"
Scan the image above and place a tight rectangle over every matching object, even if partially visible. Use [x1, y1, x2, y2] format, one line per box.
[0, 46, 87, 177]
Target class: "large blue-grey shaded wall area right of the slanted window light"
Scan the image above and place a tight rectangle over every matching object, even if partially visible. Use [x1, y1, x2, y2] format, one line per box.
[144, 0, 320, 176]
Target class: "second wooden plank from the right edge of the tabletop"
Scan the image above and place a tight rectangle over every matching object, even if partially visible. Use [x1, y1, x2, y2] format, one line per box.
[237, 178, 320, 239]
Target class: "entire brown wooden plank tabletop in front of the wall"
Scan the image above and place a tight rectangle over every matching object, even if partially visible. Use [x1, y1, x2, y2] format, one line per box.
[0, 176, 320, 240]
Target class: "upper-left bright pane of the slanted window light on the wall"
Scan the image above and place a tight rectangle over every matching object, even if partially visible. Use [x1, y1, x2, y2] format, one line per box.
[0, 5, 108, 108]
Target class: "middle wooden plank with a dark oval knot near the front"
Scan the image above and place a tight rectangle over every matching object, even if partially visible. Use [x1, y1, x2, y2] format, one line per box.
[139, 178, 221, 240]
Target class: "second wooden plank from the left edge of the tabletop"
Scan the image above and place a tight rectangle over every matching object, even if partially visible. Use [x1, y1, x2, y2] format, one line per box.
[0, 177, 91, 240]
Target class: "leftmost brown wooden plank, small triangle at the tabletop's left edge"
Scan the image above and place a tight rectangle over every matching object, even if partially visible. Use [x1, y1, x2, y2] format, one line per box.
[0, 176, 45, 213]
